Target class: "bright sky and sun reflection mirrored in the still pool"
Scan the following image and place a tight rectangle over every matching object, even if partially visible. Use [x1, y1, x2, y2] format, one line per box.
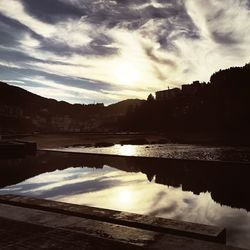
[0, 164, 250, 249]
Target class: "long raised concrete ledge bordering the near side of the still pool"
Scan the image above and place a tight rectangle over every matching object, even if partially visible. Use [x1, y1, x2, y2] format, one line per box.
[0, 195, 226, 243]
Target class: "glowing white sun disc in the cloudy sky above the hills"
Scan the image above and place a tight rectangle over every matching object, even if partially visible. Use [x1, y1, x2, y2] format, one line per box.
[113, 62, 140, 85]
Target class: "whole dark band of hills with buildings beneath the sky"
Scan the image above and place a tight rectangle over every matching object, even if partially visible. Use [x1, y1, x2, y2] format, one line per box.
[0, 64, 250, 145]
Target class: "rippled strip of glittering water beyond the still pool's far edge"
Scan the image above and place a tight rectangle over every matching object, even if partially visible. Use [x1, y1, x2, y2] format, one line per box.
[54, 143, 250, 162]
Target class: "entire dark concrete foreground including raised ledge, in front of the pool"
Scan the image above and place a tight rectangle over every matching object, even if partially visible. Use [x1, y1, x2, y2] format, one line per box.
[0, 195, 245, 250]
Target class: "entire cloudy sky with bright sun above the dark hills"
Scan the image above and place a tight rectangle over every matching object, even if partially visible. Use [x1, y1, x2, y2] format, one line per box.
[0, 0, 250, 104]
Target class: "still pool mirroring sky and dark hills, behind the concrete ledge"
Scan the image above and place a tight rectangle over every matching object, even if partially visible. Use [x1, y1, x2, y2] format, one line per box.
[0, 149, 250, 249]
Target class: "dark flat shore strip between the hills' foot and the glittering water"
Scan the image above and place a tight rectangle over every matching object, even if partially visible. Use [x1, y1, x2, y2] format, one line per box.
[9, 132, 250, 149]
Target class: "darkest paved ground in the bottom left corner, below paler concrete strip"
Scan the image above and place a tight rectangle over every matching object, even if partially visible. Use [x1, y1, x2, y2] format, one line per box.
[0, 216, 146, 250]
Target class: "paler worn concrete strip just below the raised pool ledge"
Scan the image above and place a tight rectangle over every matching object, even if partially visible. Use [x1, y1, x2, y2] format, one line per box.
[0, 204, 160, 250]
